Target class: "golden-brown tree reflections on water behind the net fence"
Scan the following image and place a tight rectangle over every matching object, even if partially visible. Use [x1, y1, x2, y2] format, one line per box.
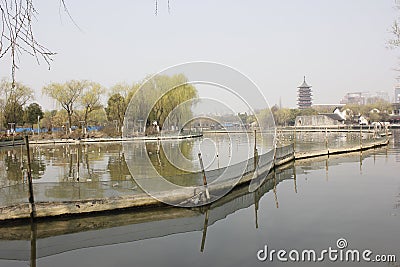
[0, 134, 260, 187]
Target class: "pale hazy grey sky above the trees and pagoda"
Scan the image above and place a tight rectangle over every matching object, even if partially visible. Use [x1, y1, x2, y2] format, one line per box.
[0, 0, 400, 108]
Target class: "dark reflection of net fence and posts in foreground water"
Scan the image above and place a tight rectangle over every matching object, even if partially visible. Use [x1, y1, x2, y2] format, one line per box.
[0, 161, 293, 266]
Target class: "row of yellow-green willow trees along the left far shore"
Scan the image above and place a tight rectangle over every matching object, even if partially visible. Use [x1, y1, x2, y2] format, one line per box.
[0, 74, 197, 138]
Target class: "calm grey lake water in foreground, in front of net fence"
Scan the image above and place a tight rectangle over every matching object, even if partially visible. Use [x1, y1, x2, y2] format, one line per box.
[0, 130, 400, 267]
